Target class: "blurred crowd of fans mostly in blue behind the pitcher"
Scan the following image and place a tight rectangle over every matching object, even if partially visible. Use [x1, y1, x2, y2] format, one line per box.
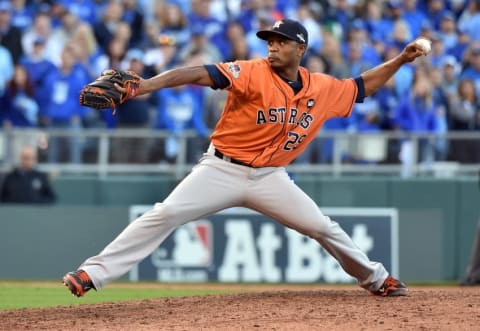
[0, 0, 480, 169]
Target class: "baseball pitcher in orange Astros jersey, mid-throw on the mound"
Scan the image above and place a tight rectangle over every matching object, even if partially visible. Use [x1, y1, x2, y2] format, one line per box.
[63, 19, 425, 297]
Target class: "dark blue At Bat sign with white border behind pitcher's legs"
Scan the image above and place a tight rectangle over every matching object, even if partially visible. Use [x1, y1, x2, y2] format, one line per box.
[130, 206, 399, 283]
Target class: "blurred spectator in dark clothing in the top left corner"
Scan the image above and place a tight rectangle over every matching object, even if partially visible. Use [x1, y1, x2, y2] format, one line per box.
[0, 0, 23, 64]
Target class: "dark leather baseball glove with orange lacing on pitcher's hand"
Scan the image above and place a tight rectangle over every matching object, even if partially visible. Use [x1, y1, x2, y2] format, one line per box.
[79, 69, 140, 113]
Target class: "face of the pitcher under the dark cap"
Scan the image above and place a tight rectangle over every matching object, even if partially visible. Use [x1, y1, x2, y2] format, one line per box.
[268, 36, 305, 68]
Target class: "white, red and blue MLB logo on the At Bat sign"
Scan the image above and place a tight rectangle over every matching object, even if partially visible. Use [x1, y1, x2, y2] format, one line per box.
[151, 220, 213, 268]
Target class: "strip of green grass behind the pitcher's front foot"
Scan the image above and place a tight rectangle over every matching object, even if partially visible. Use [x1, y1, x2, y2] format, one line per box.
[0, 282, 232, 310]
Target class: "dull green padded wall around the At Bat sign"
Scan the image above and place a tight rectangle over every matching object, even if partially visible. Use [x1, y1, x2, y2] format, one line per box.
[0, 176, 480, 281]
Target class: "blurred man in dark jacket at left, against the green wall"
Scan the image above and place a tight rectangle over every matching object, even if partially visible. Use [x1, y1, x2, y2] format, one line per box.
[0, 146, 56, 204]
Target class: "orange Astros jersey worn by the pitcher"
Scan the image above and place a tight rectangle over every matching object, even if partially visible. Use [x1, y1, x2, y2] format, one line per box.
[211, 59, 358, 167]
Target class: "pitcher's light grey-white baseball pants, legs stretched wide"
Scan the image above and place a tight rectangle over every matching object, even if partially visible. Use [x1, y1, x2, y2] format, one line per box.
[79, 145, 388, 291]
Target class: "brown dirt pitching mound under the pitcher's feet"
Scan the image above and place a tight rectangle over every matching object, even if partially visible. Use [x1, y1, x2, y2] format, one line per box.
[0, 287, 480, 331]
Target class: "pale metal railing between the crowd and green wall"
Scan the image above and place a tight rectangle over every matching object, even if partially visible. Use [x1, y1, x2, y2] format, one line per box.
[0, 129, 480, 178]
